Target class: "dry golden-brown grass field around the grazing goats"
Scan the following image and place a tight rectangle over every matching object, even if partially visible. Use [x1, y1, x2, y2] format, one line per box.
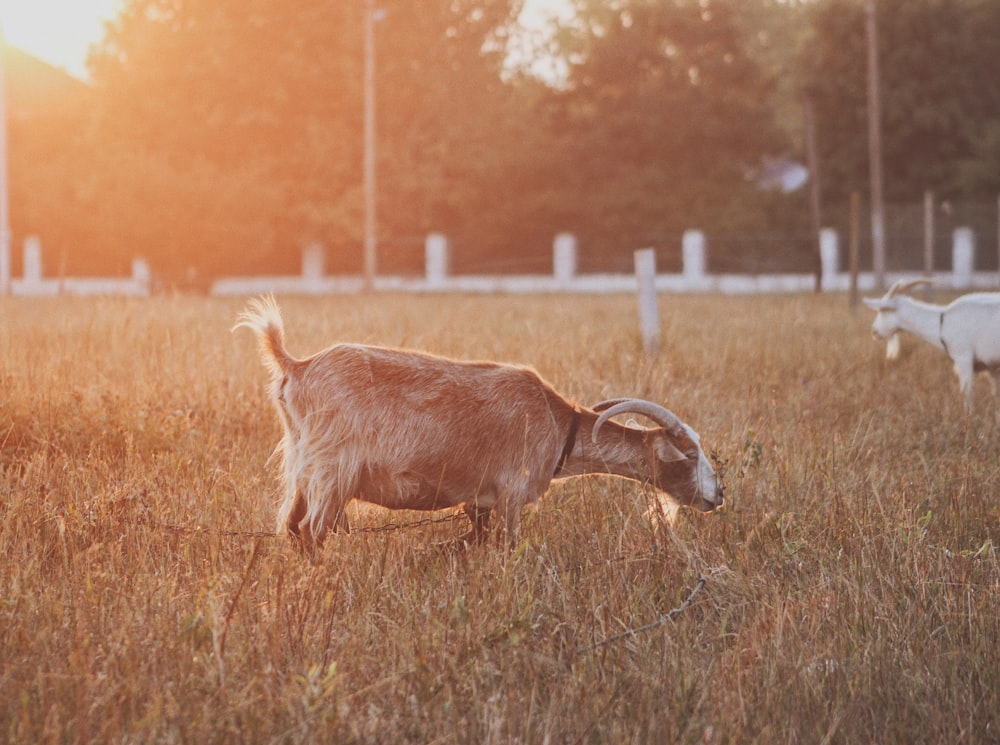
[0, 296, 1000, 744]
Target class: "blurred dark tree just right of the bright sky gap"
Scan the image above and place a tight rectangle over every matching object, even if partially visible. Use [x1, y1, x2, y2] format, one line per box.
[536, 0, 785, 268]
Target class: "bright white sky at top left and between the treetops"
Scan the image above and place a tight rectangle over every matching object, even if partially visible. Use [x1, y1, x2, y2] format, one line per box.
[0, 0, 566, 80]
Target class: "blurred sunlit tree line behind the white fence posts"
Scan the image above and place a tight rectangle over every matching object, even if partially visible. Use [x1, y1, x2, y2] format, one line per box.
[9, 0, 1000, 279]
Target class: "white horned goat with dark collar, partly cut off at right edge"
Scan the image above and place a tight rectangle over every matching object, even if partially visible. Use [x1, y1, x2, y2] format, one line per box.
[865, 279, 1000, 423]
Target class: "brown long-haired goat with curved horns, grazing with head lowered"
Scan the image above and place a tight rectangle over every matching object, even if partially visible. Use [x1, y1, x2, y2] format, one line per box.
[234, 298, 723, 548]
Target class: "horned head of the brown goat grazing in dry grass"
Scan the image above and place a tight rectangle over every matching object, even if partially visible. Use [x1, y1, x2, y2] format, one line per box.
[591, 398, 724, 512]
